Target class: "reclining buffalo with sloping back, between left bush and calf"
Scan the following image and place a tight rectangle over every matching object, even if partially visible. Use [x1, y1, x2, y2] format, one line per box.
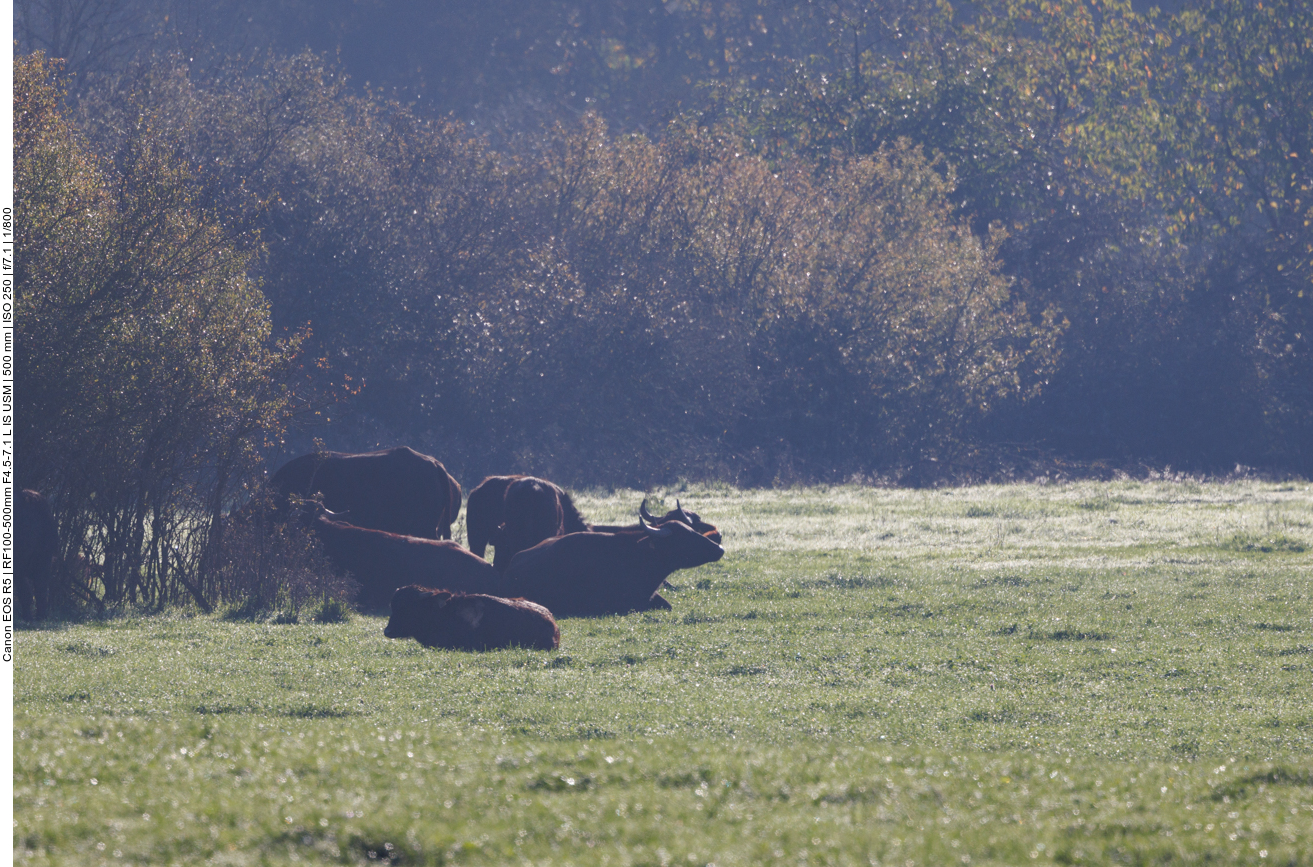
[312, 515, 500, 610]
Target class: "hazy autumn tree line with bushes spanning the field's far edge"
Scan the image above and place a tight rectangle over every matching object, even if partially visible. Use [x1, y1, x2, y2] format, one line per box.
[14, 0, 1313, 604]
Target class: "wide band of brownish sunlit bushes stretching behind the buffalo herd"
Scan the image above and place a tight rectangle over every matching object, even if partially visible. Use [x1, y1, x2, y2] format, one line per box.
[66, 55, 1060, 485]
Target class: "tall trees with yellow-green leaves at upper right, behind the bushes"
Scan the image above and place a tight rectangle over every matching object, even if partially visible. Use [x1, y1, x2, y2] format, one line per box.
[741, 0, 1313, 472]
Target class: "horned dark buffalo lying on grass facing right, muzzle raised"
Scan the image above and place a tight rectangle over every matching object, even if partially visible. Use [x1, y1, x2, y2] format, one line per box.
[506, 519, 725, 617]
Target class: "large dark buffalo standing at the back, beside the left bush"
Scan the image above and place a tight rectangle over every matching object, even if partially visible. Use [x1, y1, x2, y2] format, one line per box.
[269, 445, 461, 539]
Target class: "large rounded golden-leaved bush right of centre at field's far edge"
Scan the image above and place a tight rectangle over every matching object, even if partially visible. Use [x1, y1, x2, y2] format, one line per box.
[451, 118, 1058, 483]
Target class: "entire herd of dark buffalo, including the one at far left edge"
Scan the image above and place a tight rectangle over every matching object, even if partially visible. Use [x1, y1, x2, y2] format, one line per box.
[14, 447, 725, 650]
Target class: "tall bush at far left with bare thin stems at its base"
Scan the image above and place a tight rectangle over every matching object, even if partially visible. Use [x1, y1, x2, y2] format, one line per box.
[14, 54, 303, 606]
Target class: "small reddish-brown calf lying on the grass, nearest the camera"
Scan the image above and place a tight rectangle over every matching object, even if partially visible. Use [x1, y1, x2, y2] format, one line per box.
[383, 586, 561, 650]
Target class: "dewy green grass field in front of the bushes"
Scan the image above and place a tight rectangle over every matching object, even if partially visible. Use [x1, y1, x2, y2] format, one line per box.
[13, 482, 1313, 867]
